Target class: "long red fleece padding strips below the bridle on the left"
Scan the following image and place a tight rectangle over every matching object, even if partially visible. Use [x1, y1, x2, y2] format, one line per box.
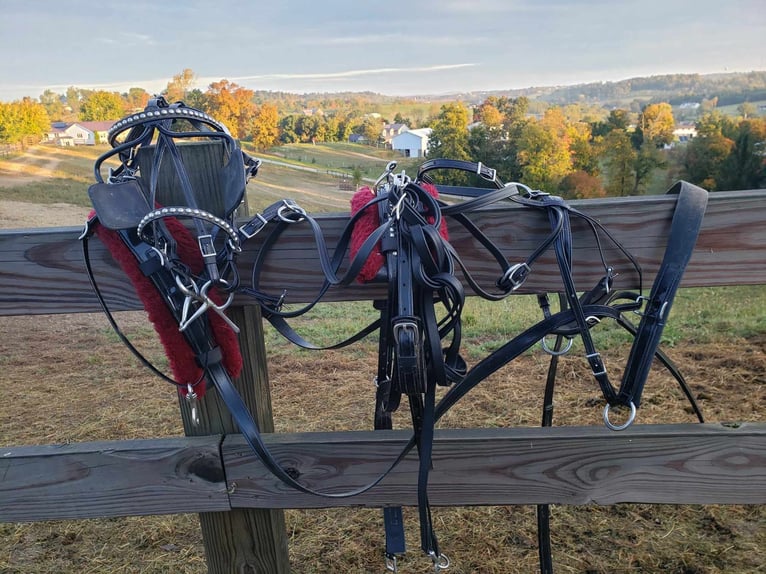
[96, 214, 242, 397]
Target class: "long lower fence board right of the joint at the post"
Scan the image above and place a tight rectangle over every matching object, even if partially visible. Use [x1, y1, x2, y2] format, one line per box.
[223, 423, 766, 508]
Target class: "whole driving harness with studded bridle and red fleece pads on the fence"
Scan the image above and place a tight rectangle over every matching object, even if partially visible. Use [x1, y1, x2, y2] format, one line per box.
[81, 98, 707, 573]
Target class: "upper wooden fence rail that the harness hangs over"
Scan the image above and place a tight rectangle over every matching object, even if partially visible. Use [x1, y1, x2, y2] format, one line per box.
[0, 190, 766, 315]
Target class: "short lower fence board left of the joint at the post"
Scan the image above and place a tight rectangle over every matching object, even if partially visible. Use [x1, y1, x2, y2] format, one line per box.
[0, 435, 230, 522]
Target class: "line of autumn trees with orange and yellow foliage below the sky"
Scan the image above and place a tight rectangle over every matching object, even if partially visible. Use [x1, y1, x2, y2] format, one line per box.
[0, 69, 766, 198]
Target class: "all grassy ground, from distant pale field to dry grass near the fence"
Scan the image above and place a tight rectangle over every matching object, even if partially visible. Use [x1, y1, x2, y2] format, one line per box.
[0, 146, 766, 574]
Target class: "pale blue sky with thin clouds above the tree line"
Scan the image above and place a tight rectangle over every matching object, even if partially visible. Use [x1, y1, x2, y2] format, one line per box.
[0, 0, 766, 102]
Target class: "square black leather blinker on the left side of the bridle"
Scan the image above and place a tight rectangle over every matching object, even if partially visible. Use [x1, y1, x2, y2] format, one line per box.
[88, 179, 151, 230]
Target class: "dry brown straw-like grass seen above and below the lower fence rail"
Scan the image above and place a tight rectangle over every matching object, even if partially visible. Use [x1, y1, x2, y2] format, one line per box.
[0, 312, 766, 574]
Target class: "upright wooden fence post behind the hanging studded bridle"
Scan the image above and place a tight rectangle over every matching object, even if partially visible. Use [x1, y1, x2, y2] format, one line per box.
[138, 142, 290, 574]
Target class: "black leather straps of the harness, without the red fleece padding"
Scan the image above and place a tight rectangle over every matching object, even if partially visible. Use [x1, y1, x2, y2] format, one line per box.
[83, 105, 707, 572]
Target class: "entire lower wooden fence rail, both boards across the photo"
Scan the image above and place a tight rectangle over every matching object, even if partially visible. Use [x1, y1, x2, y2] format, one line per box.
[0, 423, 766, 522]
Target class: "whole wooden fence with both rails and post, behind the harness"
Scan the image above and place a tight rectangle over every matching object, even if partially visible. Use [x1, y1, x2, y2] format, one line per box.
[0, 190, 766, 574]
